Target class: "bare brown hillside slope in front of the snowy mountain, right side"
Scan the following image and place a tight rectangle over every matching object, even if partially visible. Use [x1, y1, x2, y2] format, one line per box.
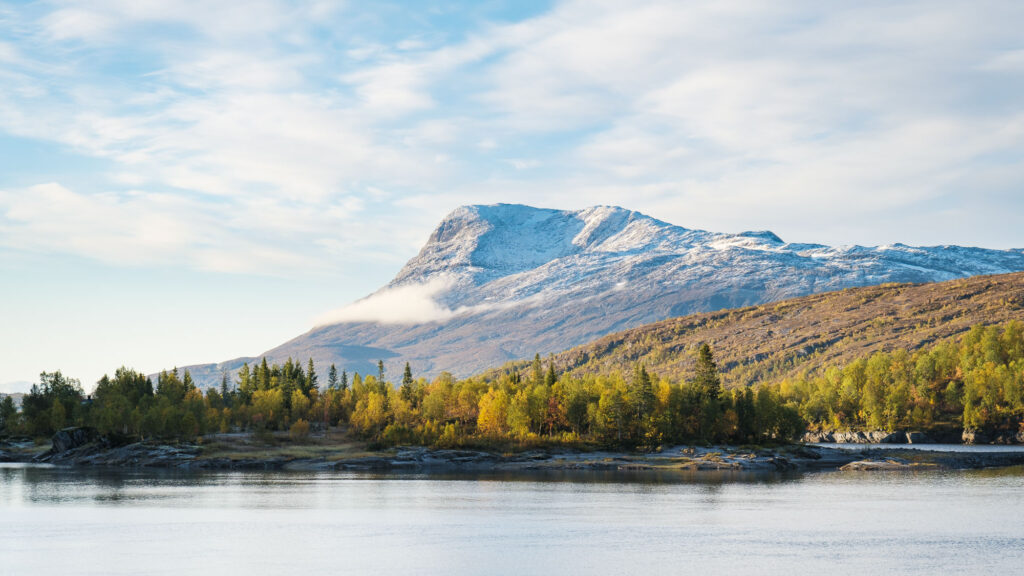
[532, 273, 1024, 386]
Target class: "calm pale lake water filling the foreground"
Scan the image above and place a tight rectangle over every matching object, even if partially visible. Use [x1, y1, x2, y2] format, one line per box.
[0, 464, 1024, 575]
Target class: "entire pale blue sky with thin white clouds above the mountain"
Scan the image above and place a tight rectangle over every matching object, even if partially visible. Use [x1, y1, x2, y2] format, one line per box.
[0, 0, 1024, 392]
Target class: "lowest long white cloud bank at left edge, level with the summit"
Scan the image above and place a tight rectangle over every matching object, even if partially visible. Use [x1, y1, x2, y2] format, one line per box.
[0, 182, 360, 276]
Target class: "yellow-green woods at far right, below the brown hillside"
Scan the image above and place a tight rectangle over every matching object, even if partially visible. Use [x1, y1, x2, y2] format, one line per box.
[770, 321, 1024, 431]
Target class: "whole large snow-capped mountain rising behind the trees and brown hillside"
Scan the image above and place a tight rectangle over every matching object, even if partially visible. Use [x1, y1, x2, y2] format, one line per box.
[180, 204, 1024, 384]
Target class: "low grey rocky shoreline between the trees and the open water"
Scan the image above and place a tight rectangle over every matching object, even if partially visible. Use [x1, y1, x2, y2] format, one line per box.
[0, 428, 1024, 472]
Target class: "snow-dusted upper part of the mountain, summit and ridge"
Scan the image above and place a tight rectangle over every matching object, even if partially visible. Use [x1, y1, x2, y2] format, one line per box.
[382, 204, 1024, 313]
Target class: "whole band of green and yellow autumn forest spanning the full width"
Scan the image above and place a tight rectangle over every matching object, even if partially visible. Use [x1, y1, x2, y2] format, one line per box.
[0, 322, 1024, 450]
